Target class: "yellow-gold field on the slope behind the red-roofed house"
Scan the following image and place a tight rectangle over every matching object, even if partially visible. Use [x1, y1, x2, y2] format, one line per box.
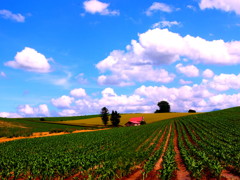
[56, 113, 199, 126]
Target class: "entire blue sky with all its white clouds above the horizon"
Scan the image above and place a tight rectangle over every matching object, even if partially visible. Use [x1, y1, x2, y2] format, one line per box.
[0, 0, 240, 117]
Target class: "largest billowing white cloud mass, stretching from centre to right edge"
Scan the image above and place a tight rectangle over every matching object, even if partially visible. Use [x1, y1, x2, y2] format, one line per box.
[96, 28, 240, 85]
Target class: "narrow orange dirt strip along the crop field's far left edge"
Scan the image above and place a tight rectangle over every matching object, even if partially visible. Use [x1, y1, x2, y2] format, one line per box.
[0, 128, 110, 143]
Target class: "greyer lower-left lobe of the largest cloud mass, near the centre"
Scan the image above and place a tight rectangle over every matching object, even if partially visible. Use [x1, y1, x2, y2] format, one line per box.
[96, 48, 175, 86]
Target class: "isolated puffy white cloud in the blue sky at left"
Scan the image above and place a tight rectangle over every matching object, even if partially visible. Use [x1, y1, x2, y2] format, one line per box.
[5, 47, 51, 73]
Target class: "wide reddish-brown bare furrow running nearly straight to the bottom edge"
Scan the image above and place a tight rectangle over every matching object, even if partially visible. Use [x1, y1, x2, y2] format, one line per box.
[173, 128, 191, 180]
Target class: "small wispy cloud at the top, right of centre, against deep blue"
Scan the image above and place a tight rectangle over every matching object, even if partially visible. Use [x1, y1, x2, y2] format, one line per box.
[146, 2, 173, 16]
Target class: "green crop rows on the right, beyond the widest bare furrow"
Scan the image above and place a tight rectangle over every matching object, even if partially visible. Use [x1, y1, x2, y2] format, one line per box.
[176, 108, 240, 178]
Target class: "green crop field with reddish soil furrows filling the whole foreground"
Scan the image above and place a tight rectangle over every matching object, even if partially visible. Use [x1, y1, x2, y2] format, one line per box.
[0, 107, 240, 180]
